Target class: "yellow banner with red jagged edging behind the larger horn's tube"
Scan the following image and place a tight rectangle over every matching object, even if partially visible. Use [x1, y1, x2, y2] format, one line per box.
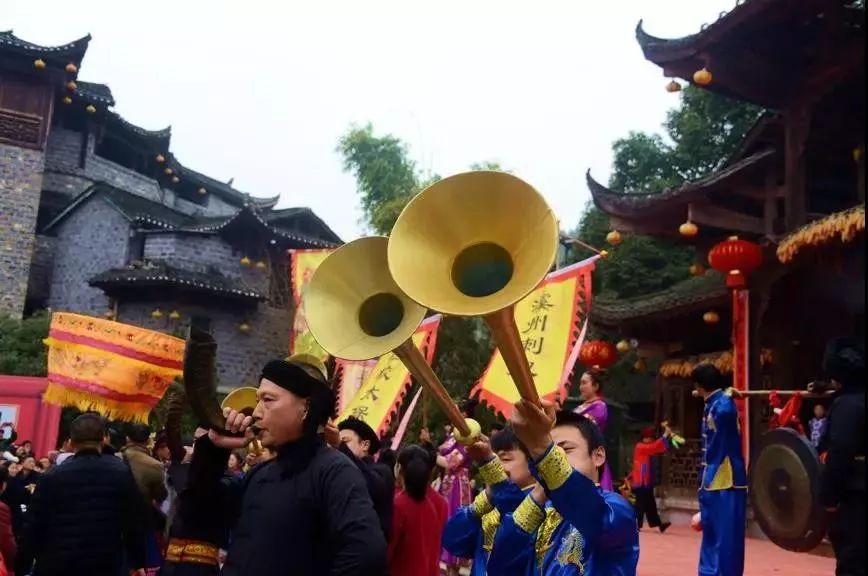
[473, 256, 598, 418]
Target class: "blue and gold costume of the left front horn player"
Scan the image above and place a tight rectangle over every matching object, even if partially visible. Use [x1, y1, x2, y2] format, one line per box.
[442, 456, 530, 576]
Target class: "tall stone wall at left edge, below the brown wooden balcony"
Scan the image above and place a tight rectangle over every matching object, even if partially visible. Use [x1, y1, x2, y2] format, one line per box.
[0, 144, 45, 318]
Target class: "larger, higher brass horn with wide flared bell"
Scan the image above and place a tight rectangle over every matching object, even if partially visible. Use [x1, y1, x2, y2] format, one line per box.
[388, 171, 559, 405]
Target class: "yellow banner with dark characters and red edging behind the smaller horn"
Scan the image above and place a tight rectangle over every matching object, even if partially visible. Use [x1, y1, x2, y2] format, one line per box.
[337, 315, 441, 435]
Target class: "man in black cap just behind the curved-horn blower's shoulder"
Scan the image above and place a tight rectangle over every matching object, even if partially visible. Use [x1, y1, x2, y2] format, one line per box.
[338, 416, 395, 541]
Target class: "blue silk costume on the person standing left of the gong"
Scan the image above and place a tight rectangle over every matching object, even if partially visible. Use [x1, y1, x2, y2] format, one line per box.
[699, 390, 747, 576]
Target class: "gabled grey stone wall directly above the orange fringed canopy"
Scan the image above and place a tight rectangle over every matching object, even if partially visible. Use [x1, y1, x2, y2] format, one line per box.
[48, 197, 130, 315]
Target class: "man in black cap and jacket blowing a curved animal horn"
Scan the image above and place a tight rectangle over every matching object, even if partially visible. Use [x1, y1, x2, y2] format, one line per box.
[195, 360, 386, 576]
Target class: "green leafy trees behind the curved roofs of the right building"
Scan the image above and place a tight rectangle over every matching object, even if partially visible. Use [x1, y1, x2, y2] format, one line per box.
[568, 86, 761, 298]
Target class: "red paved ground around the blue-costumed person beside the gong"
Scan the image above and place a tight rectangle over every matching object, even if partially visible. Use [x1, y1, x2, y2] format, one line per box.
[638, 526, 835, 576]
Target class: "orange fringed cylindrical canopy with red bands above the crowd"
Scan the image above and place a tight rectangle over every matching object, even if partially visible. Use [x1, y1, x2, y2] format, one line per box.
[43, 312, 185, 423]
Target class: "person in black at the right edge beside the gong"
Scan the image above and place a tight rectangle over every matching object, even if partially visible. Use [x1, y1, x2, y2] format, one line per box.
[820, 338, 865, 576]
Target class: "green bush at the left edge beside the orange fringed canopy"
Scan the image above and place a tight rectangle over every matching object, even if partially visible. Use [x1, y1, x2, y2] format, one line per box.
[0, 312, 51, 376]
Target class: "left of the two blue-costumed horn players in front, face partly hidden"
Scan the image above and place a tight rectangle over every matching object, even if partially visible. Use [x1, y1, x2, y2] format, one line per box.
[443, 428, 535, 576]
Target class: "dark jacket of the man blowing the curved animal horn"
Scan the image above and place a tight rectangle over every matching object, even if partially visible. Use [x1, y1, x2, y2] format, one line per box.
[193, 436, 386, 576]
